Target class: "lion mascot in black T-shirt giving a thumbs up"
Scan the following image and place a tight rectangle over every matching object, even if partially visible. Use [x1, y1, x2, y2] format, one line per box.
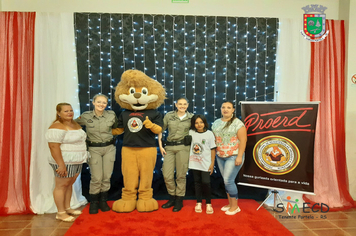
[112, 70, 166, 212]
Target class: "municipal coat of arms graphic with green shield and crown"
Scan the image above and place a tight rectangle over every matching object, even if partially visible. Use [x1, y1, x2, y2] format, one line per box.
[300, 4, 329, 42]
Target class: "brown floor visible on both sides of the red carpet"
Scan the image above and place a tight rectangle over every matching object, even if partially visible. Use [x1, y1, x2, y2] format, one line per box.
[0, 203, 356, 236]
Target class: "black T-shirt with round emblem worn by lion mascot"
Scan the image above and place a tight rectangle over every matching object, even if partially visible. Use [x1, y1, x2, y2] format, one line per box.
[118, 110, 163, 147]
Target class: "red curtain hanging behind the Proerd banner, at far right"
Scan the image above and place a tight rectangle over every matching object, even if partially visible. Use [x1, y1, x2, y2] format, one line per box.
[304, 20, 355, 210]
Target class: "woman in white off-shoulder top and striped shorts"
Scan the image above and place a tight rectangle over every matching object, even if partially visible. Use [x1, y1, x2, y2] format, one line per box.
[46, 103, 87, 222]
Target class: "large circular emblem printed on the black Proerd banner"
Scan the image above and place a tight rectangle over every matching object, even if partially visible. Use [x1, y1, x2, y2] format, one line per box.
[253, 135, 300, 175]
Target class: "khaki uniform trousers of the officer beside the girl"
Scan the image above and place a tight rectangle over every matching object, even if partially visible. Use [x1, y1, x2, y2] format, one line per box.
[162, 145, 190, 197]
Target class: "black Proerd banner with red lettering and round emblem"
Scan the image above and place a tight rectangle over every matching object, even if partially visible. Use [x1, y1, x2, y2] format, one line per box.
[239, 102, 319, 194]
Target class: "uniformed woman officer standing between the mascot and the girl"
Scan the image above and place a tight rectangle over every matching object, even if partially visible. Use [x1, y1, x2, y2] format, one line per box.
[158, 97, 193, 212]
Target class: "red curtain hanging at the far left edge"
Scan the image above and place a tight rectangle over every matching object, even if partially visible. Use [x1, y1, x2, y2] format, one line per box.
[0, 12, 36, 215]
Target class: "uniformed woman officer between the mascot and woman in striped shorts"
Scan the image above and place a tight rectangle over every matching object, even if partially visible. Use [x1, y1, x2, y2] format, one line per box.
[76, 94, 117, 214]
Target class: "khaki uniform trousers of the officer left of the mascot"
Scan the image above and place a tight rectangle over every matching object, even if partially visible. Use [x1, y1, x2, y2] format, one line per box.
[89, 144, 116, 194]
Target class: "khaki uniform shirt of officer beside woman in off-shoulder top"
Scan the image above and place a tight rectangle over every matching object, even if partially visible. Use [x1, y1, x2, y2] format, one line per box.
[75, 110, 117, 143]
